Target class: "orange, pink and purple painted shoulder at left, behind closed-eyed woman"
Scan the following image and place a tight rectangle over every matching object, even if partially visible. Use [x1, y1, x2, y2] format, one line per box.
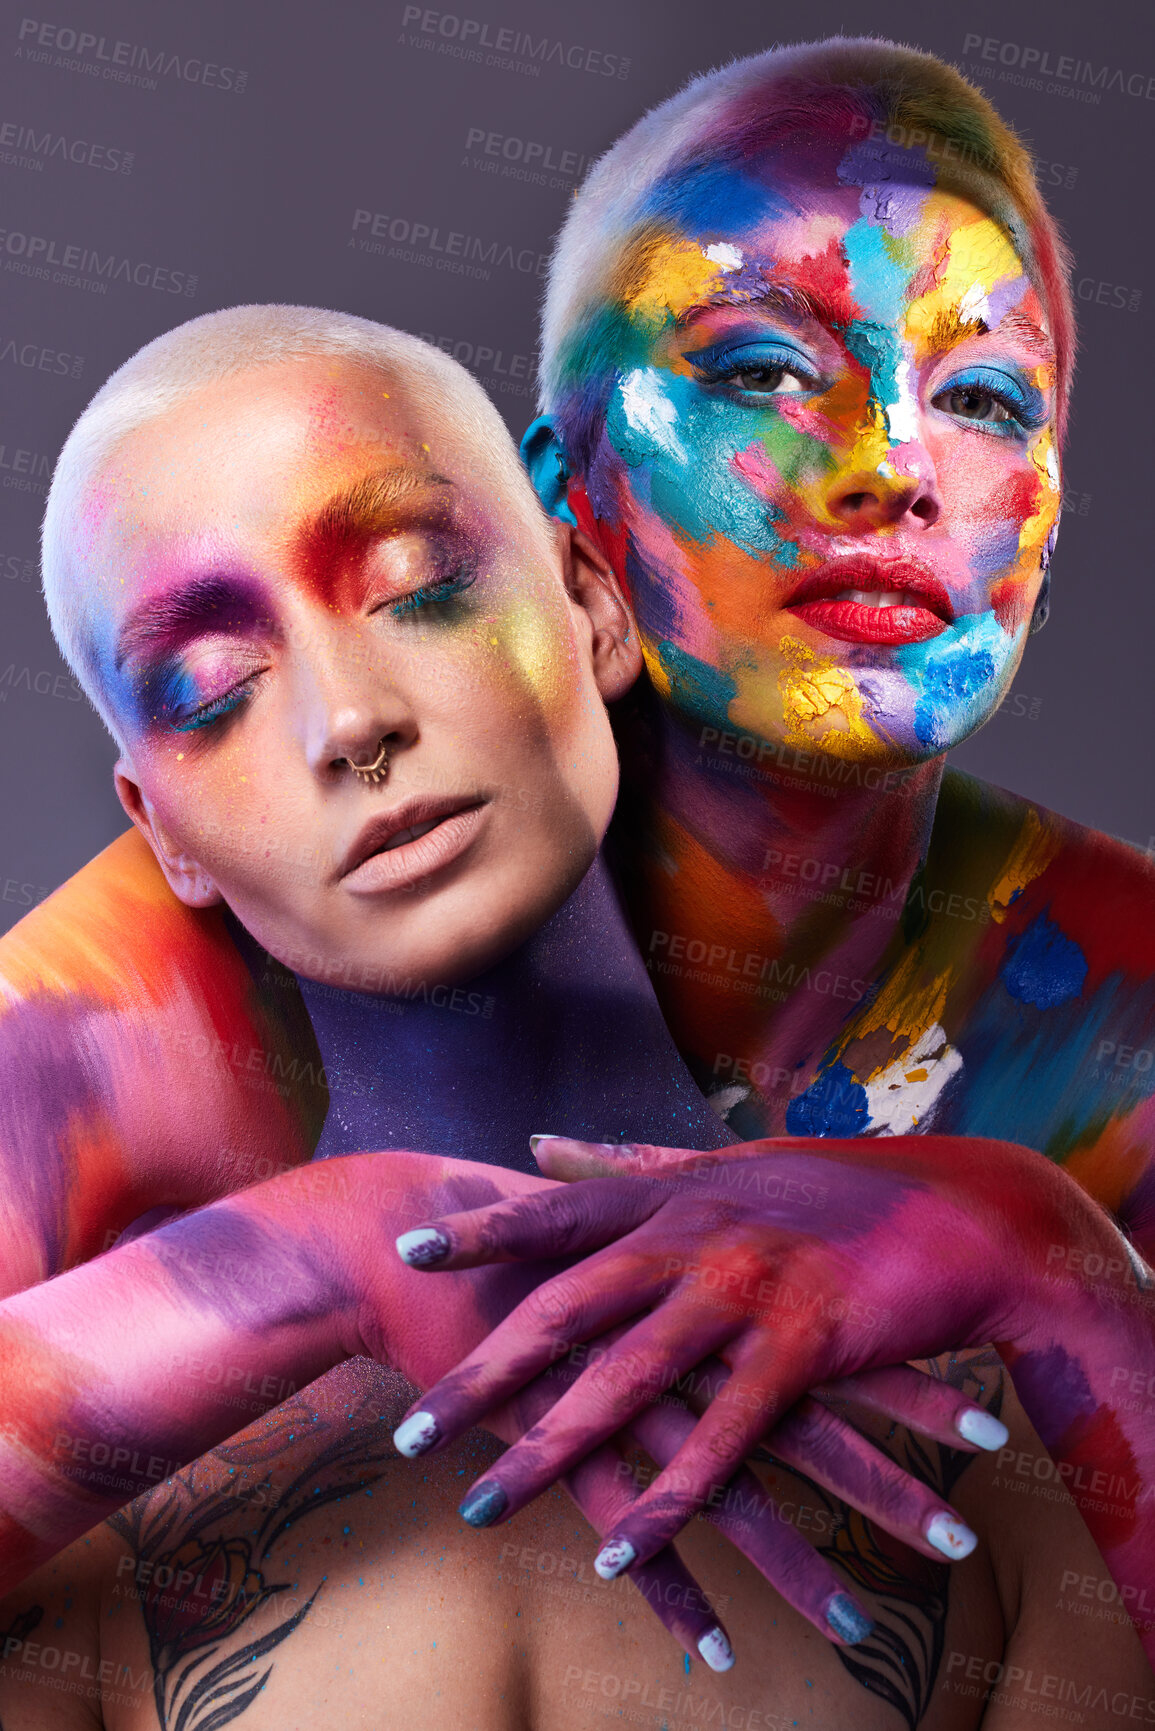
[0, 829, 329, 1297]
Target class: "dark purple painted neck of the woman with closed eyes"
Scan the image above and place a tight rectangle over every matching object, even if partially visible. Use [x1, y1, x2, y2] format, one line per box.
[300, 857, 732, 1172]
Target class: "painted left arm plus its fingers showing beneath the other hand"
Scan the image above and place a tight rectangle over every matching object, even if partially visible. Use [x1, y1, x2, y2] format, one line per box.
[0, 1153, 1004, 1662]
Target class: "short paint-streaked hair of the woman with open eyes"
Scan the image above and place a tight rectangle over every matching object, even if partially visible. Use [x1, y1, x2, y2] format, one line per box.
[539, 36, 1075, 469]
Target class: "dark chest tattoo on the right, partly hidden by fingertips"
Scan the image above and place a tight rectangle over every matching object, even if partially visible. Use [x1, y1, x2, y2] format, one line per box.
[754, 1350, 1006, 1731]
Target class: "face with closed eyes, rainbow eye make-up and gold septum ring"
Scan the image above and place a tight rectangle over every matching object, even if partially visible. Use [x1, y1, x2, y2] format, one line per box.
[85, 357, 625, 990]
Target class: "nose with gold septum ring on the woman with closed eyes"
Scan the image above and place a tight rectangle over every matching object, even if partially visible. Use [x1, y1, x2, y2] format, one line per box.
[293, 630, 417, 781]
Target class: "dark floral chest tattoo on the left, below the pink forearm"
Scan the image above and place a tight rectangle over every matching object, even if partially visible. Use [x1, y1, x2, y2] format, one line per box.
[109, 1397, 397, 1731]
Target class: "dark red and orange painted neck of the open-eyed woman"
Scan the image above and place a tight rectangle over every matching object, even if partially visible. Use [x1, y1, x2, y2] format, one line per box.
[613, 687, 945, 1087]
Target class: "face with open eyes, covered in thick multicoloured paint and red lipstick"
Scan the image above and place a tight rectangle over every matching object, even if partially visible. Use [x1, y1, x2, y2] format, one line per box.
[558, 144, 1060, 762]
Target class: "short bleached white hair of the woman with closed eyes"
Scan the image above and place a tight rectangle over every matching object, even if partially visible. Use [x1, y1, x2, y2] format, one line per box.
[40, 305, 544, 744]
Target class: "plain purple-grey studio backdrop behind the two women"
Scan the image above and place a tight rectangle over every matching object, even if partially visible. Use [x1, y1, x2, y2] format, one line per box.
[0, 0, 1155, 930]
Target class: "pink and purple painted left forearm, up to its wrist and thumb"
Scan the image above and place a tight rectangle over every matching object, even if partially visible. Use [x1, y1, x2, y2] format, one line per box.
[0, 1153, 547, 1591]
